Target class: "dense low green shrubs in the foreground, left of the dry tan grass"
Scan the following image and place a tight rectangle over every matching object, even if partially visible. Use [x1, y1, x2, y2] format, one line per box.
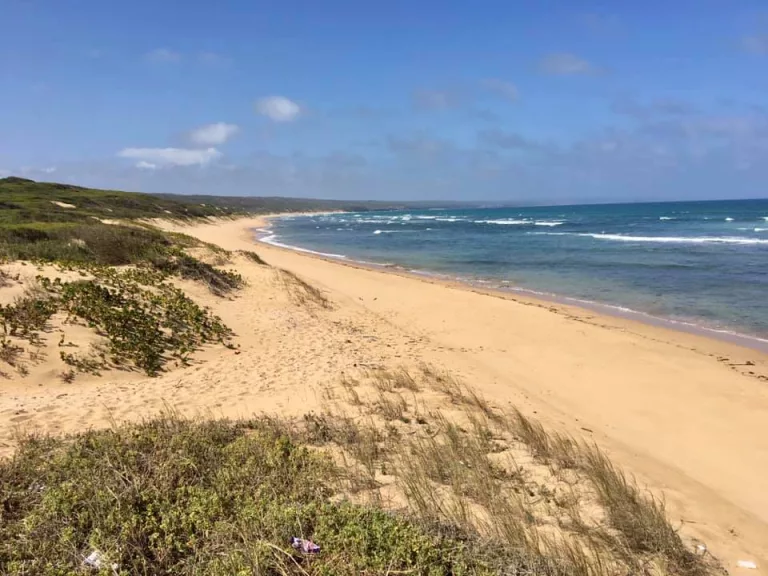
[0, 417, 497, 575]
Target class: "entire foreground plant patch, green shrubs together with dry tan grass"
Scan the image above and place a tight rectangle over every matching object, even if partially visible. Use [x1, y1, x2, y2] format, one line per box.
[0, 368, 718, 576]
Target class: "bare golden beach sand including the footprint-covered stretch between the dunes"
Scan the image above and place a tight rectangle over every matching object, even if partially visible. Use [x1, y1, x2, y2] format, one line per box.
[0, 218, 768, 574]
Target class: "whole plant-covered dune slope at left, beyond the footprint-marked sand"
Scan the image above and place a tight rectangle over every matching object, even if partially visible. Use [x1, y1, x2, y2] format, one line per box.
[0, 178, 244, 381]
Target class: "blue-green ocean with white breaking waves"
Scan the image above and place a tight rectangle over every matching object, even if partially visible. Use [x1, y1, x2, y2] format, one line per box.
[260, 200, 768, 348]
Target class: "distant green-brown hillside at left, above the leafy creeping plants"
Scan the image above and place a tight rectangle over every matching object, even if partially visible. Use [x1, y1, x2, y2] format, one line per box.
[0, 178, 249, 295]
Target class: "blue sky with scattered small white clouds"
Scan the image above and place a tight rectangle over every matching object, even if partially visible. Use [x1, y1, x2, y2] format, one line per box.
[0, 0, 768, 203]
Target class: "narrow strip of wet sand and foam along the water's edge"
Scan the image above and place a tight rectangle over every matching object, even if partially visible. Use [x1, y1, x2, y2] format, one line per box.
[260, 212, 768, 353]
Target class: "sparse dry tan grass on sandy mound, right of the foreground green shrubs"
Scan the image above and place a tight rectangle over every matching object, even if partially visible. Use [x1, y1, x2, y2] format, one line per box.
[308, 366, 721, 576]
